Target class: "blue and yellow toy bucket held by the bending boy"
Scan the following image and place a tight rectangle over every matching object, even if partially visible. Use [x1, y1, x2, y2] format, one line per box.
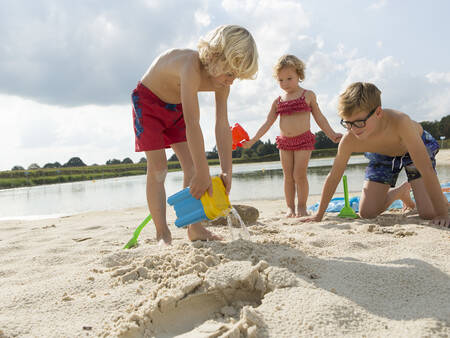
[167, 176, 231, 228]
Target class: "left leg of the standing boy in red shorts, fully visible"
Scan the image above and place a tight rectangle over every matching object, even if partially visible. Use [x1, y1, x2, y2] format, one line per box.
[145, 149, 172, 244]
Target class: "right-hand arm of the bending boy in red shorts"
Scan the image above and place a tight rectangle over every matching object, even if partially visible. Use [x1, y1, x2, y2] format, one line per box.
[215, 86, 233, 194]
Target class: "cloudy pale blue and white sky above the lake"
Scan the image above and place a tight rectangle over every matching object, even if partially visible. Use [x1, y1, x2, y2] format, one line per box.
[0, 0, 450, 170]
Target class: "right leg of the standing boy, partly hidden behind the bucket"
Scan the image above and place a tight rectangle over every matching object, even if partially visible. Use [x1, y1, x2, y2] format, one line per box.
[171, 142, 222, 241]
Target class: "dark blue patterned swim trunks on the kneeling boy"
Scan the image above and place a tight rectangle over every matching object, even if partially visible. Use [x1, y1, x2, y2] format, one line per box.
[364, 130, 439, 187]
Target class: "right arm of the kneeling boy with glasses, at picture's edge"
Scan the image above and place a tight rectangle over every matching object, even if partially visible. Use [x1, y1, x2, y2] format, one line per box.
[398, 115, 450, 227]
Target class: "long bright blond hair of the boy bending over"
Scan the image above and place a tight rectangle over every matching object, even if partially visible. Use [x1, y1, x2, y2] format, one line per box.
[198, 25, 258, 79]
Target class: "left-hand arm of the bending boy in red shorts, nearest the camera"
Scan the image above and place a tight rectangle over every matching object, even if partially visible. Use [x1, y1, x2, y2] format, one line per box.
[180, 60, 212, 199]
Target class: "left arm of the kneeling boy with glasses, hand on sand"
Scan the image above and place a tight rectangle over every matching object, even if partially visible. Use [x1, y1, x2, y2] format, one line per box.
[300, 134, 353, 222]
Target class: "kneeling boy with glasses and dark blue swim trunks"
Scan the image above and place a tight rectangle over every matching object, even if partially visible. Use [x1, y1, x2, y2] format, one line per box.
[302, 82, 450, 227]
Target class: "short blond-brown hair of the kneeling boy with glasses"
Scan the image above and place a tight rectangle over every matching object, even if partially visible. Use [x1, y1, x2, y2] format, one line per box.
[338, 82, 381, 118]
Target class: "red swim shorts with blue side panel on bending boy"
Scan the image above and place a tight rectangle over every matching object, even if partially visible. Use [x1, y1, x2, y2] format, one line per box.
[131, 82, 186, 151]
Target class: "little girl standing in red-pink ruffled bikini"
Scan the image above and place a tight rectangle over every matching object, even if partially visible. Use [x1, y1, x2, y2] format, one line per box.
[243, 55, 342, 217]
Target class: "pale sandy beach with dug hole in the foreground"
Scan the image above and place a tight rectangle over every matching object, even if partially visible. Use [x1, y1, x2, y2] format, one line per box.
[0, 151, 450, 337]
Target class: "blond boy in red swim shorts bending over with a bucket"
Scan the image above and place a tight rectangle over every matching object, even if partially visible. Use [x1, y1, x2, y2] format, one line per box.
[132, 25, 258, 244]
